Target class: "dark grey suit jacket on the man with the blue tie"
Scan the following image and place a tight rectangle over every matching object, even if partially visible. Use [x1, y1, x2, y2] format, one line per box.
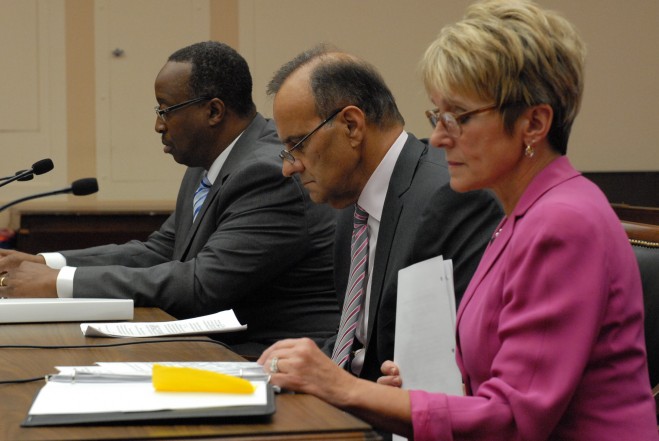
[62, 115, 339, 355]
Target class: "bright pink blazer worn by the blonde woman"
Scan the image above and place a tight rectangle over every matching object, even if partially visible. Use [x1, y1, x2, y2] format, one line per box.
[410, 157, 659, 441]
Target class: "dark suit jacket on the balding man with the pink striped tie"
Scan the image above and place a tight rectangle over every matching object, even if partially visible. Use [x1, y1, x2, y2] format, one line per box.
[323, 134, 503, 381]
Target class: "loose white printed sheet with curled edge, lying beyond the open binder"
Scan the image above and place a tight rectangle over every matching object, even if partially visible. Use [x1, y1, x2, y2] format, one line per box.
[80, 309, 247, 337]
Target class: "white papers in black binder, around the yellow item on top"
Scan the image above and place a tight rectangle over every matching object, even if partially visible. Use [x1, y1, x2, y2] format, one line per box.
[23, 362, 275, 426]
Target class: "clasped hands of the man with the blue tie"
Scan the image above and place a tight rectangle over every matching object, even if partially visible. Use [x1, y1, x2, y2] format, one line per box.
[0, 260, 59, 297]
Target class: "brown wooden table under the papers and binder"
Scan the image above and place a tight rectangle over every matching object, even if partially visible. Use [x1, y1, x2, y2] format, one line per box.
[0, 308, 379, 441]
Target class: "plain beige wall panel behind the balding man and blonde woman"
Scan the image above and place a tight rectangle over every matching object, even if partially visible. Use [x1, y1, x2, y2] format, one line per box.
[240, 0, 659, 171]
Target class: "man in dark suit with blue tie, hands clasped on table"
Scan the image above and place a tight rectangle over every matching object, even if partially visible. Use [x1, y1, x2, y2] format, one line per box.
[0, 42, 339, 355]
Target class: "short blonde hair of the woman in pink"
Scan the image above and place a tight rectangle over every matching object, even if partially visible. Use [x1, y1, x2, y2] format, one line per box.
[421, 0, 586, 154]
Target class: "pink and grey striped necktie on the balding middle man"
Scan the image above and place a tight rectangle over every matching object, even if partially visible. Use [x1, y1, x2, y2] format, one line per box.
[332, 204, 368, 367]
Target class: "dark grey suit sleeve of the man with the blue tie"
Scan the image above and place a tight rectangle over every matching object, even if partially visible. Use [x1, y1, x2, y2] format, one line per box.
[67, 161, 318, 318]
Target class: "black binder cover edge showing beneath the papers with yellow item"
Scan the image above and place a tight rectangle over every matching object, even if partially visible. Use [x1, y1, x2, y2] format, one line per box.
[21, 384, 275, 427]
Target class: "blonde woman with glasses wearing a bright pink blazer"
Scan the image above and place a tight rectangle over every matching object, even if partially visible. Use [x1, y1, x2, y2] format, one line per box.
[261, 0, 659, 441]
